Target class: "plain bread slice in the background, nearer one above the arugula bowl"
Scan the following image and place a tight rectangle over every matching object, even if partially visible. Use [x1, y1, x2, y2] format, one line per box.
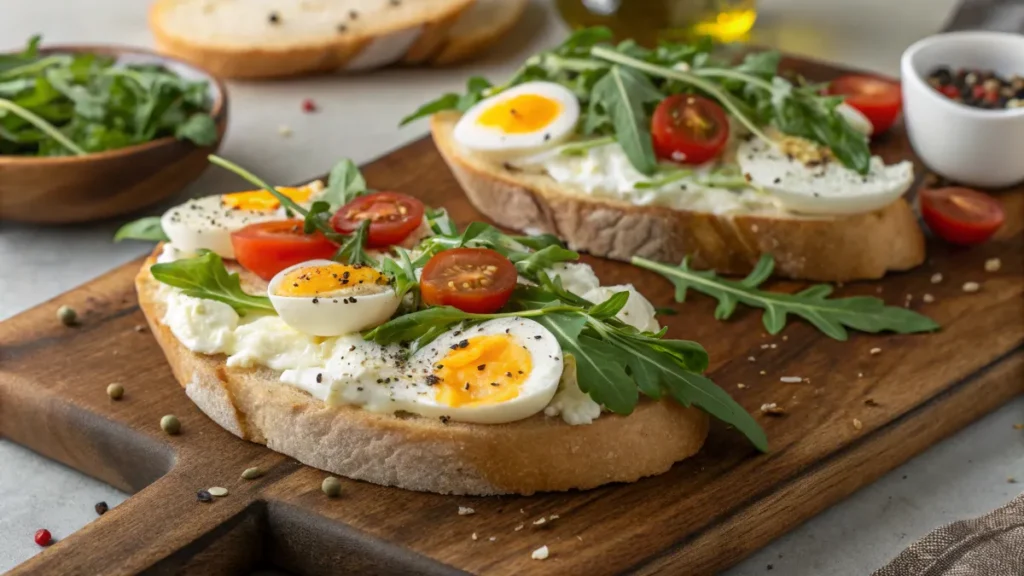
[150, 0, 473, 78]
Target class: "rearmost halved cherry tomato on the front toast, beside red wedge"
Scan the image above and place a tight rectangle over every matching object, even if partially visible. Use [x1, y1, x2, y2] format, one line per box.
[331, 192, 423, 248]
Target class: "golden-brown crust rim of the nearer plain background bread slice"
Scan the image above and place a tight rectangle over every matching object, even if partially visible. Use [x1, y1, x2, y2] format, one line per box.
[148, 0, 473, 79]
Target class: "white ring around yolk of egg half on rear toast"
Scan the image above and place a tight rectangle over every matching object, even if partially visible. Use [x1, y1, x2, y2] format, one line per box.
[454, 82, 580, 158]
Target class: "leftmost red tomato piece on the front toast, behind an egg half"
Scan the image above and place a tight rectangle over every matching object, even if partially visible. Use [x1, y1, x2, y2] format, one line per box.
[231, 220, 338, 280]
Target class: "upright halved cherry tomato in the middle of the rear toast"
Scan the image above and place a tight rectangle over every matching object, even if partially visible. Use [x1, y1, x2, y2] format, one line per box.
[650, 94, 729, 164]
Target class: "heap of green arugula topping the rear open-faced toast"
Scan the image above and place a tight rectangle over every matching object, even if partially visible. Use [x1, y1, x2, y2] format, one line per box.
[402, 28, 870, 175]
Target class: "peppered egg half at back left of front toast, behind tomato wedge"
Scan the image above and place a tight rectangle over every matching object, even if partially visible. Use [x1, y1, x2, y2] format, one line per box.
[160, 180, 324, 259]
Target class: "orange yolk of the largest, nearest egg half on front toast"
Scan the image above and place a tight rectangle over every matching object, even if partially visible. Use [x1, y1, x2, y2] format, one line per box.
[434, 334, 532, 408]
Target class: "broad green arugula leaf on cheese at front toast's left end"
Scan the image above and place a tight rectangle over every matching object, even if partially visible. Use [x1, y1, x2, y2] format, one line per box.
[150, 250, 273, 316]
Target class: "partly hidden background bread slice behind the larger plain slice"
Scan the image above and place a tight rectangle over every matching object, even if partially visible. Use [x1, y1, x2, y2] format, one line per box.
[406, 0, 529, 66]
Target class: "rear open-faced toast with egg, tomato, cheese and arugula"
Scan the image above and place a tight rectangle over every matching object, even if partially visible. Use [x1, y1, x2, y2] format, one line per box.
[404, 29, 925, 281]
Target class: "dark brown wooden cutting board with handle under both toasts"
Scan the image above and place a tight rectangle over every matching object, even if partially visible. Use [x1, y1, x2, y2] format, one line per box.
[0, 54, 1024, 575]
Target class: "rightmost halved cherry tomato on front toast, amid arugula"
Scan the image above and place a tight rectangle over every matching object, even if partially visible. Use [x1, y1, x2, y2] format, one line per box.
[420, 243, 519, 314]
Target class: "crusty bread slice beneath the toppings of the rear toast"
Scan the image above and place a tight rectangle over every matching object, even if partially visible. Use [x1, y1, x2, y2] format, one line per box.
[430, 112, 925, 282]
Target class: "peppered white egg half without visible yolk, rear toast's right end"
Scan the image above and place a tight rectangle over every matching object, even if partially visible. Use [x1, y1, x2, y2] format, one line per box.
[736, 136, 913, 215]
